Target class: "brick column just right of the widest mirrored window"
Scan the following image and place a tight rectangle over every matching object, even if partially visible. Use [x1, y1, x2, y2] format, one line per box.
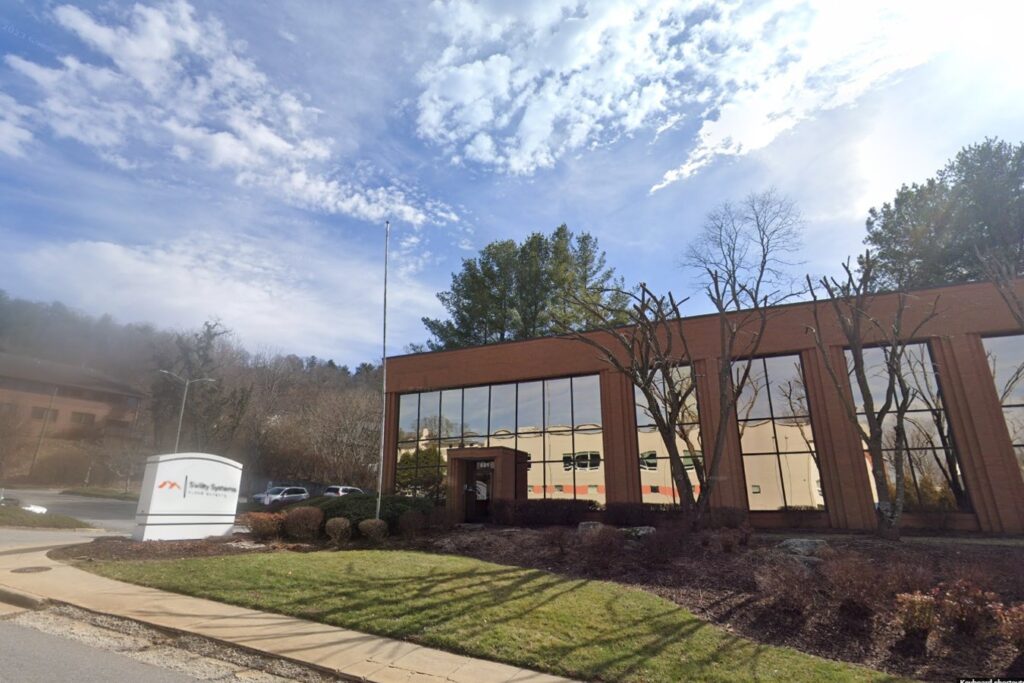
[601, 369, 642, 503]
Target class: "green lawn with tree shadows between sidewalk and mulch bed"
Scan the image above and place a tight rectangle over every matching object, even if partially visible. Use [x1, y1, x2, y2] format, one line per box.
[92, 551, 892, 681]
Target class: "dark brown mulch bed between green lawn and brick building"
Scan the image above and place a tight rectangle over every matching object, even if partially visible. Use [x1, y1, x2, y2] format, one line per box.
[50, 526, 1024, 680]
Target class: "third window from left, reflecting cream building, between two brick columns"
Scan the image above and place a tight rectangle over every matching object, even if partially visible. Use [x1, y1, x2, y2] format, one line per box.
[733, 354, 825, 511]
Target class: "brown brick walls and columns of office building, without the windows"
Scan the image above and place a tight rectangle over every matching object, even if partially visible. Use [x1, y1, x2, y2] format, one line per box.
[384, 281, 1024, 533]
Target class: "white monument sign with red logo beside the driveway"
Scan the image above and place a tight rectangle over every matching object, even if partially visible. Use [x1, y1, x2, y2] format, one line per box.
[132, 453, 242, 541]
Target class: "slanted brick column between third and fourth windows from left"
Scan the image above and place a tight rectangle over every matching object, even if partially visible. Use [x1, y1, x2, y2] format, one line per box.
[800, 347, 877, 529]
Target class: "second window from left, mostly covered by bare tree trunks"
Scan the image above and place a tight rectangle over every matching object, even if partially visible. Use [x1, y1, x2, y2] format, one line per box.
[633, 366, 703, 505]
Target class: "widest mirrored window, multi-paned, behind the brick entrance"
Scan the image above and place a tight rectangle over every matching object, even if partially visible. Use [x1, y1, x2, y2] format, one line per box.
[395, 375, 605, 504]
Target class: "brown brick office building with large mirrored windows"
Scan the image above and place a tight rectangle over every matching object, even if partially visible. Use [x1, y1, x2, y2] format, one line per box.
[384, 281, 1024, 533]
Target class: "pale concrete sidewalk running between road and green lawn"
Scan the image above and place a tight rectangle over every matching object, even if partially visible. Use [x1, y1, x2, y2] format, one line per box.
[0, 548, 567, 683]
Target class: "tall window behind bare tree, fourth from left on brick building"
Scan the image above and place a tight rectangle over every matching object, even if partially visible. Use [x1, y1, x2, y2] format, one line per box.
[847, 344, 971, 512]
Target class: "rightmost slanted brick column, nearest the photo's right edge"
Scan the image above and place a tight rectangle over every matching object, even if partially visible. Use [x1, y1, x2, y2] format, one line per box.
[931, 335, 1024, 533]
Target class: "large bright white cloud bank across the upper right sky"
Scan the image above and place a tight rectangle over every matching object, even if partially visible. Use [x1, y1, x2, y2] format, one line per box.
[418, 0, 1021, 191]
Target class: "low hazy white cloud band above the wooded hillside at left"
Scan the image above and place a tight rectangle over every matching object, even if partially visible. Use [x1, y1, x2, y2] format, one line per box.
[10, 232, 438, 361]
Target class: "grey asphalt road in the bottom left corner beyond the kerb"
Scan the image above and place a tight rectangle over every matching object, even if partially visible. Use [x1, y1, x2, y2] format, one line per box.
[0, 622, 197, 683]
